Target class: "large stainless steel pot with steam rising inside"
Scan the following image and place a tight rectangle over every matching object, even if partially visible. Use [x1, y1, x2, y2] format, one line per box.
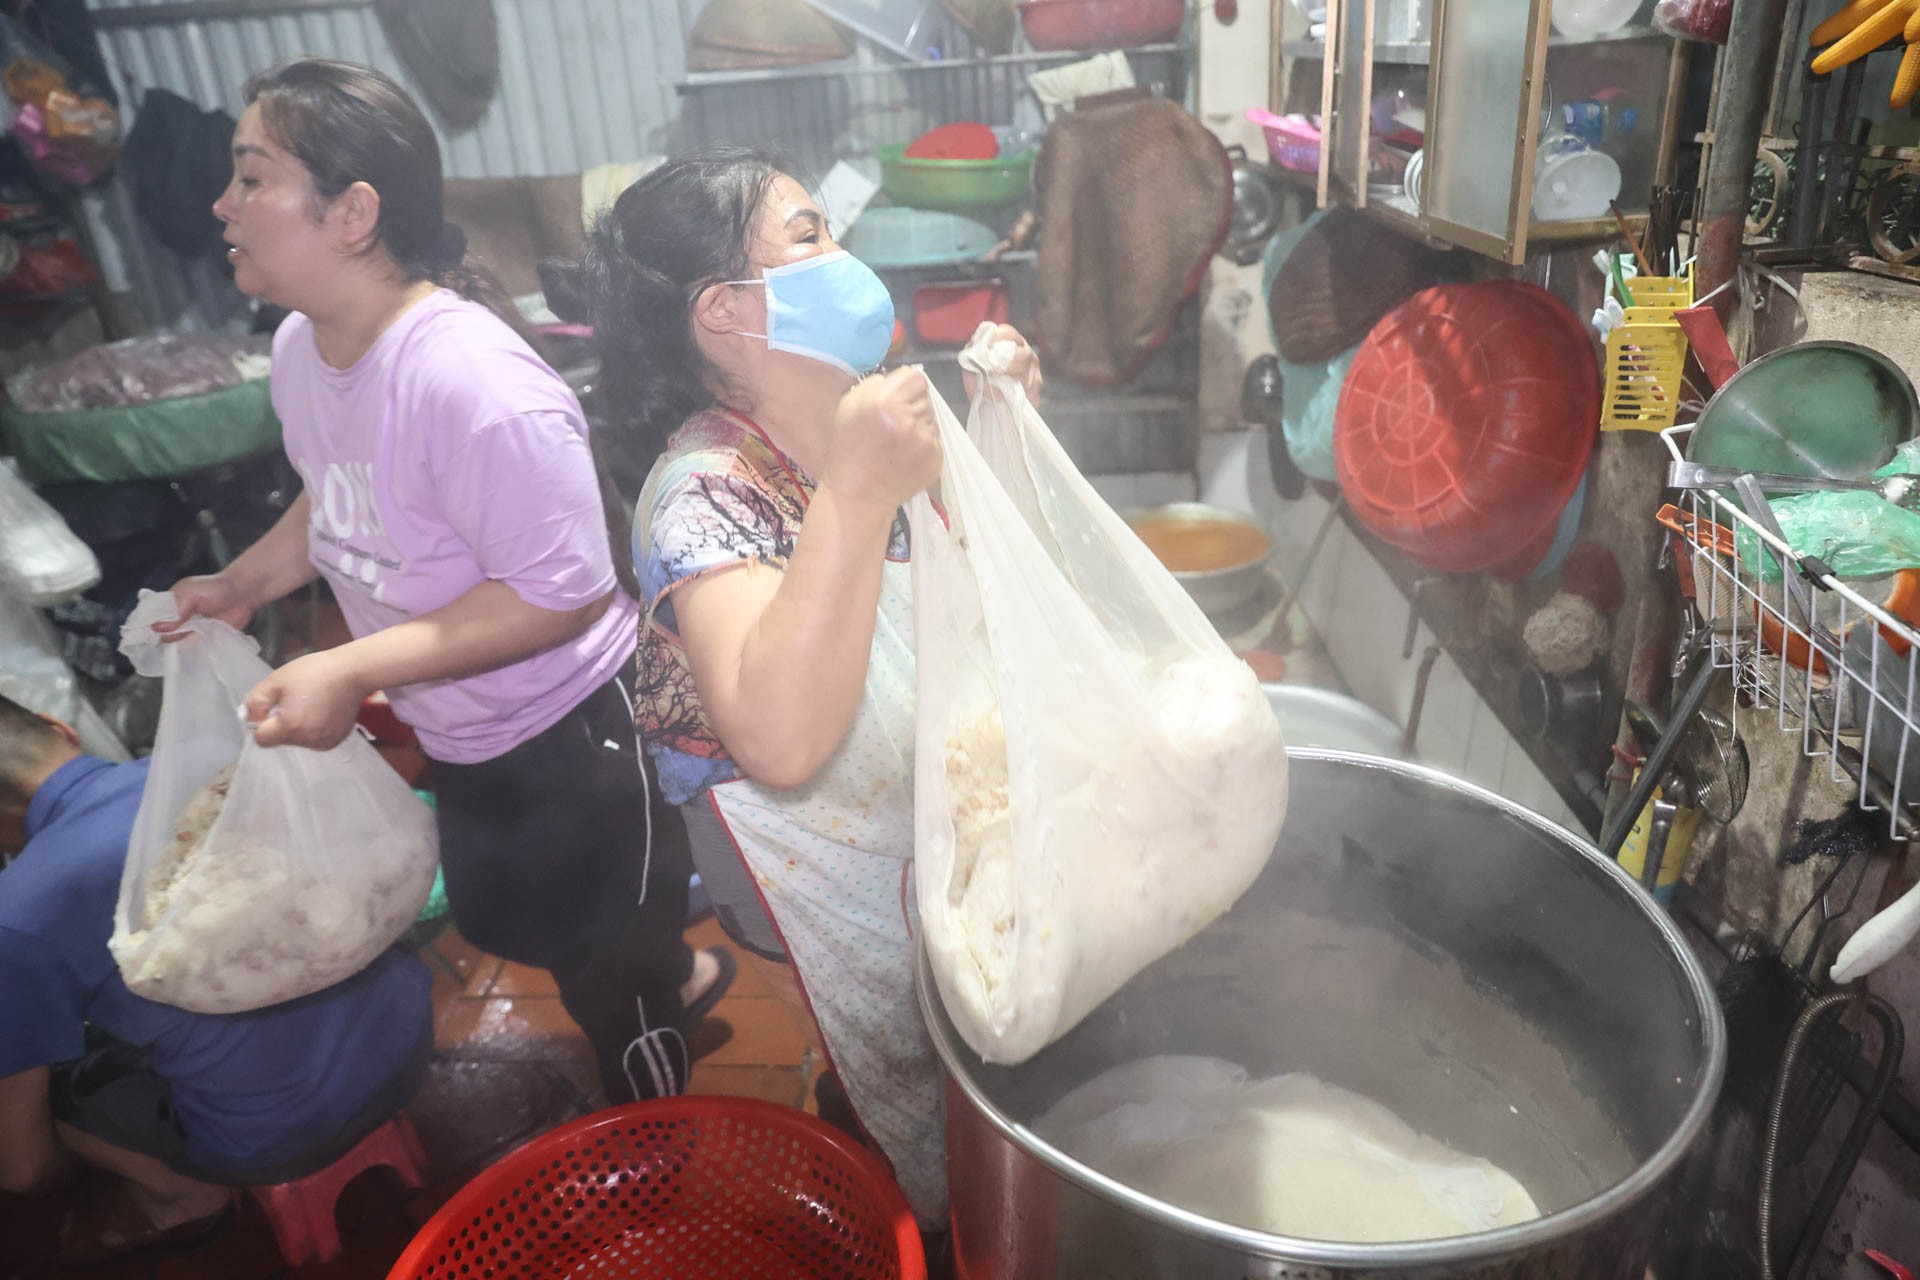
[920, 750, 1726, 1280]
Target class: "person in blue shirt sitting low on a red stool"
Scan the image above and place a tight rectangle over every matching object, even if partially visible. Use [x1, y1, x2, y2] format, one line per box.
[0, 697, 432, 1265]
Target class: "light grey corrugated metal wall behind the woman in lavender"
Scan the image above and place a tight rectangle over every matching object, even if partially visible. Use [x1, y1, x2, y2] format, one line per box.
[88, 0, 699, 178]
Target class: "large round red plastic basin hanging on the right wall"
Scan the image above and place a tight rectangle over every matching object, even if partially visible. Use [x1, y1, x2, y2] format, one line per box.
[1332, 280, 1601, 572]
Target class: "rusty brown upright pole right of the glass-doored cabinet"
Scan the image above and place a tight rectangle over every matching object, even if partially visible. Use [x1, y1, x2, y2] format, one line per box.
[1693, 0, 1788, 310]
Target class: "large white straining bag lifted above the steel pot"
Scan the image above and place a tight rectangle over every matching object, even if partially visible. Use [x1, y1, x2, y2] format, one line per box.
[908, 326, 1286, 1063]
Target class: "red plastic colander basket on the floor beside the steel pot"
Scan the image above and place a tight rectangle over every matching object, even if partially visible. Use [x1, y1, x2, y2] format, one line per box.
[388, 1098, 927, 1280]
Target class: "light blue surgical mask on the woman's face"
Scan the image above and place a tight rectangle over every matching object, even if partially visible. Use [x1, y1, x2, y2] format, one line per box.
[728, 249, 893, 378]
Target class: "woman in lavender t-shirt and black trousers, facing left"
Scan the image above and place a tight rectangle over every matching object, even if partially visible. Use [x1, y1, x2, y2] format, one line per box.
[157, 59, 726, 1102]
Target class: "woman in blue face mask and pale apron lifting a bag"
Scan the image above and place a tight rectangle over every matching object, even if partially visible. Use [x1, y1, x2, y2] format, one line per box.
[549, 150, 1039, 1226]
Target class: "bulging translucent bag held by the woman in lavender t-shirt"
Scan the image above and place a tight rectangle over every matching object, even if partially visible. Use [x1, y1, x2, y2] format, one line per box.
[109, 591, 440, 1013]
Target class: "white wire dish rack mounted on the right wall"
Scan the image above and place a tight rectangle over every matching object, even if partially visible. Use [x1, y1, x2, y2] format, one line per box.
[1661, 422, 1920, 839]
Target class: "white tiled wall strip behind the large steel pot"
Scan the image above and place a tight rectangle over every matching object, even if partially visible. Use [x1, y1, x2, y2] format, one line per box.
[1200, 432, 1578, 829]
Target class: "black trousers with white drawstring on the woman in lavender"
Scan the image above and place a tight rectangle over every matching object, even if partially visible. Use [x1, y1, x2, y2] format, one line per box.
[432, 677, 693, 1103]
